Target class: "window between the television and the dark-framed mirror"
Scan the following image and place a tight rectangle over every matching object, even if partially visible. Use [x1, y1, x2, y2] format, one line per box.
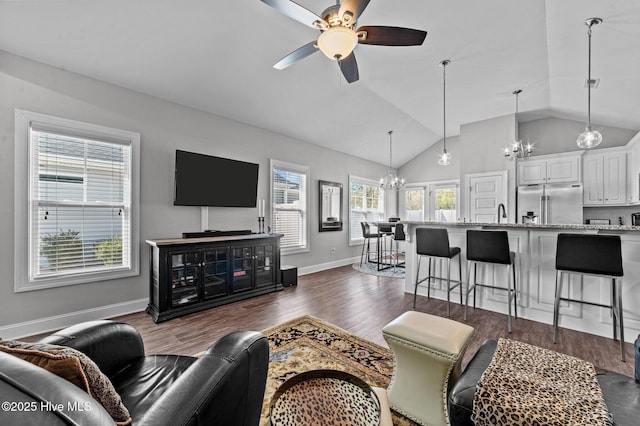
[271, 160, 309, 254]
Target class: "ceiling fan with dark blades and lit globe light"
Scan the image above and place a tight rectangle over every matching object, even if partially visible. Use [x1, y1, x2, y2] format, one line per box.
[261, 0, 427, 83]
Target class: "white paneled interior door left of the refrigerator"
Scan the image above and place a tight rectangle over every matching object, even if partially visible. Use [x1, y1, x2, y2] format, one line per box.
[465, 170, 509, 223]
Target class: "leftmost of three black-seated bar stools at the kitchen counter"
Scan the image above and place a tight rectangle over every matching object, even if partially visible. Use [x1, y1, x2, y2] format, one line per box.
[413, 228, 462, 316]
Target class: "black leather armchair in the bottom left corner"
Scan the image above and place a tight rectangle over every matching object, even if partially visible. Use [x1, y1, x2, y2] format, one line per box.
[0, 320, 269, 426]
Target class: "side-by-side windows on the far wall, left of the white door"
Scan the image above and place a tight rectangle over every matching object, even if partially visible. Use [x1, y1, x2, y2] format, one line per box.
[400, 180, 459, 222]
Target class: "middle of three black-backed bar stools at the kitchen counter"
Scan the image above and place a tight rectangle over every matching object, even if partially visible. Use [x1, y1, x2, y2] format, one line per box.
[464, 230, 518, 333]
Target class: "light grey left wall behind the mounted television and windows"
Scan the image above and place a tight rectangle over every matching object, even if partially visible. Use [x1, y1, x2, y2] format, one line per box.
[0, 51, 397, 332]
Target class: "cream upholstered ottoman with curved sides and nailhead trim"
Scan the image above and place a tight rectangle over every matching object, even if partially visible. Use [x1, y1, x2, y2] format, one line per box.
[382, 311, 473, 425]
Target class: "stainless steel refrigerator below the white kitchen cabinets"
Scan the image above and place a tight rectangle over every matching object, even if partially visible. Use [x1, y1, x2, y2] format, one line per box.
[516, 184, 583, 224]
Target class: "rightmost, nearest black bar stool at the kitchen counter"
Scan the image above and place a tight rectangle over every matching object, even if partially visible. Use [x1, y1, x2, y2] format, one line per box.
[553, 234, 625, 361]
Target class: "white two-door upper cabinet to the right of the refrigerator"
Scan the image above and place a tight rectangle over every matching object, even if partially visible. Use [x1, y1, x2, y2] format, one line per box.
[582, 150, 627, 206]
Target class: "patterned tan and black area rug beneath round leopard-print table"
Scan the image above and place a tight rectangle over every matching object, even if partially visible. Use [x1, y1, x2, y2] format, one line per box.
[260, 315, 415, 426]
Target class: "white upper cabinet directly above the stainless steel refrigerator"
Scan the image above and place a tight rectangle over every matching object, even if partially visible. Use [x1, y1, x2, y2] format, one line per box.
[518, 152, 582, 185]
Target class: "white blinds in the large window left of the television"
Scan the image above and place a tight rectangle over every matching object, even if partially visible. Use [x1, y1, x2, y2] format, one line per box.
[29, 125, 131, 280]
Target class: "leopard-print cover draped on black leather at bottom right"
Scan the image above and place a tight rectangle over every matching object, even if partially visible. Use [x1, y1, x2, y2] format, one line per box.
[472, 339, 613, 425]
